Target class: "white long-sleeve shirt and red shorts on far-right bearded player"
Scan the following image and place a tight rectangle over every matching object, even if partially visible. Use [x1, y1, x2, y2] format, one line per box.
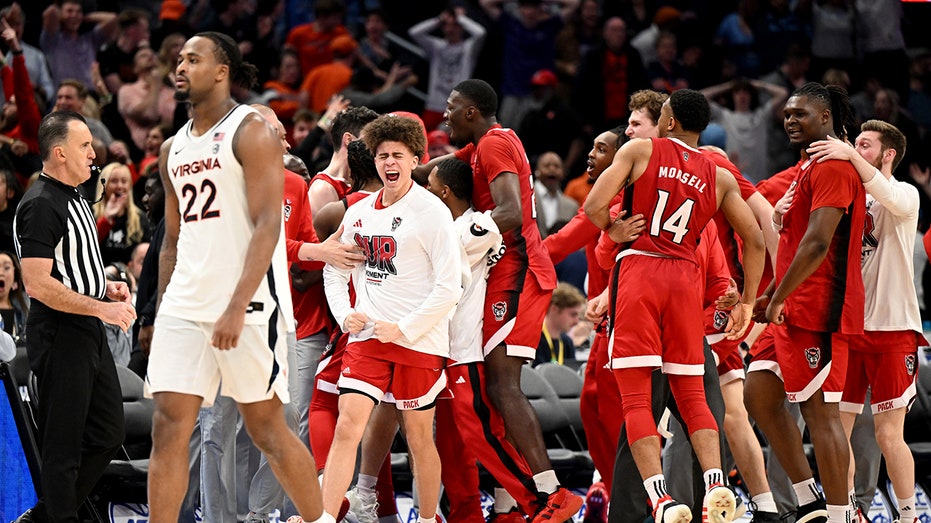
[840, 171, 927, 414]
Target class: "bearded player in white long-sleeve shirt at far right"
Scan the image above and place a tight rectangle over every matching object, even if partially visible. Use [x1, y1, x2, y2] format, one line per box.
[808, 120, 927, 523]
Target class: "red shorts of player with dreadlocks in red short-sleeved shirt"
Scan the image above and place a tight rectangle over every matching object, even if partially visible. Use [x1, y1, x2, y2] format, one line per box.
[773, 324, 848, 403]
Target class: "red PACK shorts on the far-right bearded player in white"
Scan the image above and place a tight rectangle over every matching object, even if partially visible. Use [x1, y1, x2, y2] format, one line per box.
[840, 331, 919, 414]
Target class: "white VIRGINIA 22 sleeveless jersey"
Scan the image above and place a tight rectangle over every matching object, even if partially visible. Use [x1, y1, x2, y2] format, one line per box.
[158, 105, 294, 332]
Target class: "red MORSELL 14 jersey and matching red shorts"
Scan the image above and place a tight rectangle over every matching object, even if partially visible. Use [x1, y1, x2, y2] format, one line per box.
[611, 138, 718, 375]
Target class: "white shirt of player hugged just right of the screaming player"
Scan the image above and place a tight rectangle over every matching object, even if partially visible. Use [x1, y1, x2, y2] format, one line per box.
[449, 209, 504, 365]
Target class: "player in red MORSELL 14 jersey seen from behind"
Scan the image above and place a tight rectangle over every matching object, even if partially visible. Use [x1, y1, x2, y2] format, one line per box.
[584, 89, 765, 523]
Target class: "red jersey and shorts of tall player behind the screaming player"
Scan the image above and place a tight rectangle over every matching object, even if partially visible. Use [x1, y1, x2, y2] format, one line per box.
[456, 125, 556, 359]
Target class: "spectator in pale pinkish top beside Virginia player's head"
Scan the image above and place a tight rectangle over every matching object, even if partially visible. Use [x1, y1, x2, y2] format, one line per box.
[117, 47, 176, 151]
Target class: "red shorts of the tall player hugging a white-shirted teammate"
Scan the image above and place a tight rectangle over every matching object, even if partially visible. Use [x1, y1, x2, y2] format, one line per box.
[482, 273, 553, 360]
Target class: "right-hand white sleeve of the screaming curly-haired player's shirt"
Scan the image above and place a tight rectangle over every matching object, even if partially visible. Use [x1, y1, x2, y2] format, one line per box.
[398, 209, 464, 342]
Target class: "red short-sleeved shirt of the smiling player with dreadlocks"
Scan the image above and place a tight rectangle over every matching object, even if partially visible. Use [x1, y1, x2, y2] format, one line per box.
[776, 160, 866, 334]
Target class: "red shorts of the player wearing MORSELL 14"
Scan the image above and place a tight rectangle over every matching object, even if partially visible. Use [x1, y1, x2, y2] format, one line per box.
[609, 254, 705, 376]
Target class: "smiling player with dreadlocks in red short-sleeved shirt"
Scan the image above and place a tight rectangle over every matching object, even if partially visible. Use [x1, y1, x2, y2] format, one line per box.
[747, 82, 866, 523]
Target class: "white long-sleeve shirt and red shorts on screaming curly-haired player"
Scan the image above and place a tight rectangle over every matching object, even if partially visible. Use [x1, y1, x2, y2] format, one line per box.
[323, 184, 464, 408]
